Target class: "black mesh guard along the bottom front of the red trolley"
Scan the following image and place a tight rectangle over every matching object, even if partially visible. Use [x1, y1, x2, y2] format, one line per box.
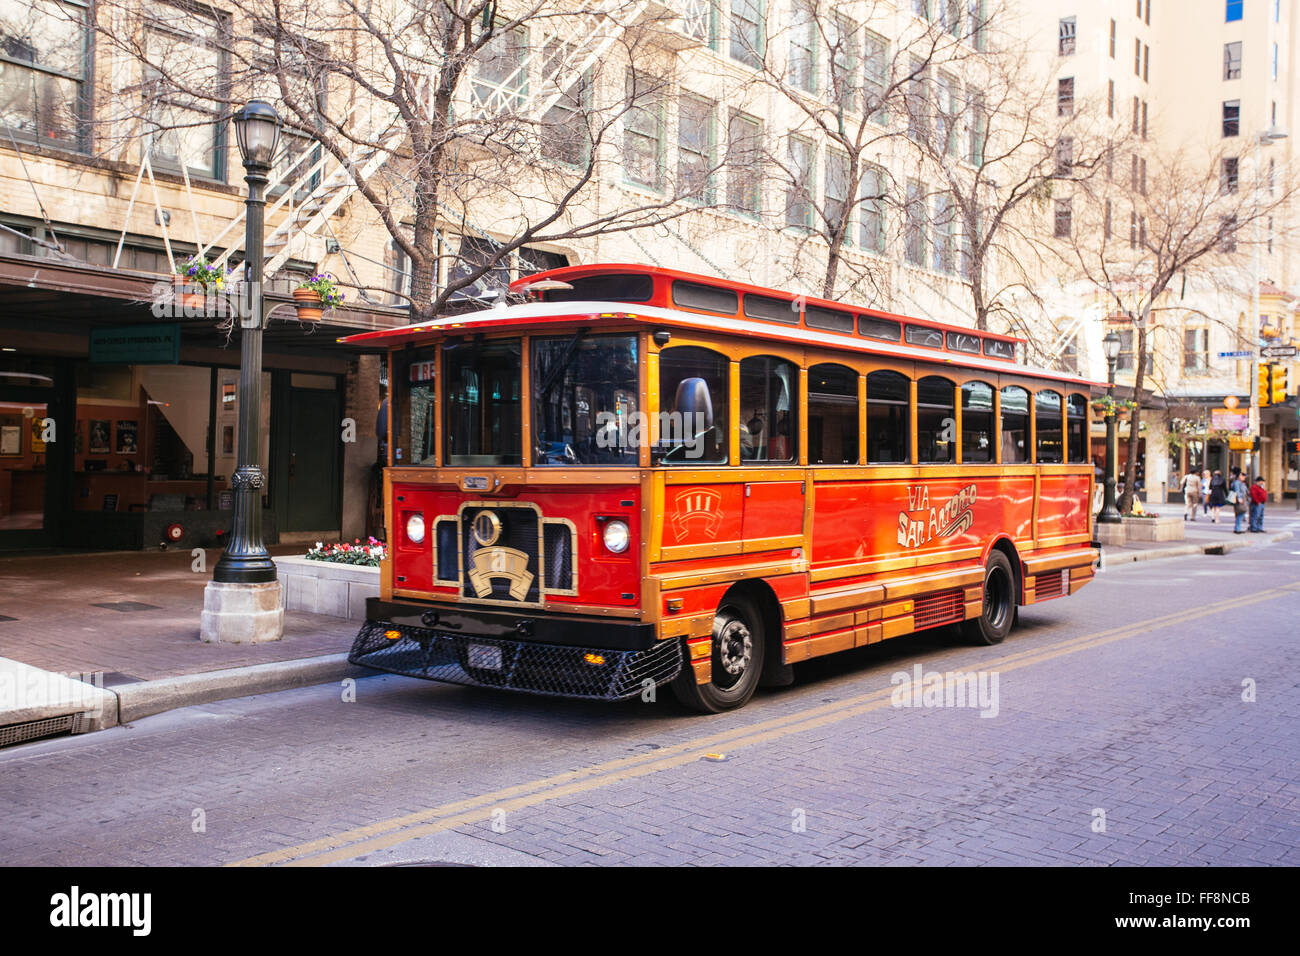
[347, 620, 683, 700]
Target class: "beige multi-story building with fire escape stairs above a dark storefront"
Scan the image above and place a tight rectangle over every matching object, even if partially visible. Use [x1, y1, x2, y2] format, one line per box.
[0, 0, 1029, 546]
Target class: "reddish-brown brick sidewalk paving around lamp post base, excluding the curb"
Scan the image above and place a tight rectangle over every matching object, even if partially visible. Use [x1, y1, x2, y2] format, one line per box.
[0, 546, 358, 680]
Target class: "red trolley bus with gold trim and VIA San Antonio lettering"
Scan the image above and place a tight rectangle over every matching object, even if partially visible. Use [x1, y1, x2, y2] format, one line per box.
[347, 265, 1097, 711]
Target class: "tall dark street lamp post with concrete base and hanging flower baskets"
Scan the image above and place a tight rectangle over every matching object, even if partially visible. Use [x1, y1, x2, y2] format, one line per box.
[202, 100, 283, 643]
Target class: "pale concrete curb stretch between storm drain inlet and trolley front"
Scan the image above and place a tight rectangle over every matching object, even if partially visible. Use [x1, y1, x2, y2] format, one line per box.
[113, 654, 374, 730]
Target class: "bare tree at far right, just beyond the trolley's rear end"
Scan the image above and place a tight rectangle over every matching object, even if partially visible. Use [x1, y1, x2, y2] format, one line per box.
[1063, 148, 1297, 512]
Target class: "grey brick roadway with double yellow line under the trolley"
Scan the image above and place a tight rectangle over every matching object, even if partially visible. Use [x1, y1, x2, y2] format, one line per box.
[0, 522, 1300, 865]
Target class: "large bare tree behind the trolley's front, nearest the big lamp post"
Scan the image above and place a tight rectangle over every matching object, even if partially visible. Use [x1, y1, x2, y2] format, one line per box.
[86, 0, 717, 321]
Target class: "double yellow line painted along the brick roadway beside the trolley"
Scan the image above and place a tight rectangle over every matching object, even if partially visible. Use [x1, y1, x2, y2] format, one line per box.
[228, 584, 1300, 866]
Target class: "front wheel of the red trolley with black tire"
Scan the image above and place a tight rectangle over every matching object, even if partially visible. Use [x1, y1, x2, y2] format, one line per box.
[672, 594, 767, 714]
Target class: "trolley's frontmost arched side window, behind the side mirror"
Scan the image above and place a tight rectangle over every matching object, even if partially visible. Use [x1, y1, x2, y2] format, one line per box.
[654, 346, 731, 466]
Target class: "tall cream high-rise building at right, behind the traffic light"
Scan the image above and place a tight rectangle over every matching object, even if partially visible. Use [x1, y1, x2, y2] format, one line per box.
[1022, 0, 1300, 501]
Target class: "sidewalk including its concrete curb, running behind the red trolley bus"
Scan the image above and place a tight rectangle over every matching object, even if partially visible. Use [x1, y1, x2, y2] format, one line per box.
[0, 520, 1300, 747]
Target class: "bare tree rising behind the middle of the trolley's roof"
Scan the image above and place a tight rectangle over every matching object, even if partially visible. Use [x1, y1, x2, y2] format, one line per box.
[732, 0, 989, 298]
